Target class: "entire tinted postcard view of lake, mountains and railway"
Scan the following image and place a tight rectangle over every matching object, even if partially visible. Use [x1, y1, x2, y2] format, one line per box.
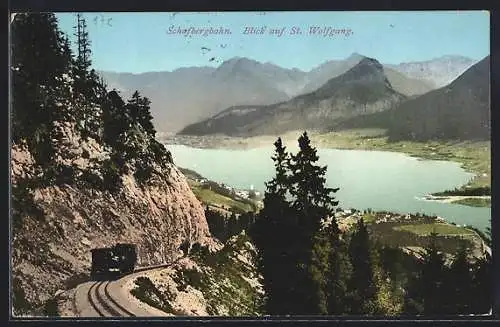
[9, 12, 492, 319]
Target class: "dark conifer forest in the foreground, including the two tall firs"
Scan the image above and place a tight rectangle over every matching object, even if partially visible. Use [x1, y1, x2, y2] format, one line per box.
[246, 133, 492, 316]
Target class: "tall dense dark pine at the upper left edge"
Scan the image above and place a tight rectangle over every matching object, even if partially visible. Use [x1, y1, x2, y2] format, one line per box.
[11, 13, 70, 167]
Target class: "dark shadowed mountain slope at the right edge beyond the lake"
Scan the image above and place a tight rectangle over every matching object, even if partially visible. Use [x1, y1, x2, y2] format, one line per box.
[332, 56, 491, 141]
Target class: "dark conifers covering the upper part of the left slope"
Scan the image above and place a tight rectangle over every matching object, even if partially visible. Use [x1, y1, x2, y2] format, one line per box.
[11, 13, 172, 192]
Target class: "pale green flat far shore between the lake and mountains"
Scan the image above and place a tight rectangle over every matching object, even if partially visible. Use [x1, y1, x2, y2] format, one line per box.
[162, 130, 491, 207]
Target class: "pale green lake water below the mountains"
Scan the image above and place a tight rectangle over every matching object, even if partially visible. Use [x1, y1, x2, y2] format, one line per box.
[166, 145, 491, 230]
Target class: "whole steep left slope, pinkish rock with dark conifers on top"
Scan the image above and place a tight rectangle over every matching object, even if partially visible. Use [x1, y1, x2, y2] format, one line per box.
[10, 13, 214, 315]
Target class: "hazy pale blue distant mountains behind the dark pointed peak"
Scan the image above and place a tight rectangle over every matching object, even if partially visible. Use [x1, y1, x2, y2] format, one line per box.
[100, 53, 474, 133]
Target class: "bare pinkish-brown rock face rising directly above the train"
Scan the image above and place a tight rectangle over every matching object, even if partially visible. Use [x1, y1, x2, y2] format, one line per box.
[11, 139, 215, 314]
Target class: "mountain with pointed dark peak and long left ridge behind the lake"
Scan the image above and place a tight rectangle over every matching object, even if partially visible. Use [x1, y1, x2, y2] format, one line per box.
[180, 58, 407, 136]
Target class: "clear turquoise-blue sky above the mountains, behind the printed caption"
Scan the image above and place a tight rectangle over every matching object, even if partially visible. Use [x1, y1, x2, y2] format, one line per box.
[57, 11, 490, 73]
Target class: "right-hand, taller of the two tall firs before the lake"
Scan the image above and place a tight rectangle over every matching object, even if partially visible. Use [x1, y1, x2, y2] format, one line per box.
[288, 132, 338, 314]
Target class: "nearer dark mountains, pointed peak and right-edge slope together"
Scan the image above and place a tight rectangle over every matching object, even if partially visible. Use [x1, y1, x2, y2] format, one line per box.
[180, 57, 490, 140]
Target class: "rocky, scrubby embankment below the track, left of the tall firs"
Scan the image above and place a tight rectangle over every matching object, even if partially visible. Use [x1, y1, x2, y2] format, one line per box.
[125, 233, 263, 316]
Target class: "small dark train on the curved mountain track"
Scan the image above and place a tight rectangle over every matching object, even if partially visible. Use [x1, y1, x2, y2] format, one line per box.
[90, 243, 137, 278]
